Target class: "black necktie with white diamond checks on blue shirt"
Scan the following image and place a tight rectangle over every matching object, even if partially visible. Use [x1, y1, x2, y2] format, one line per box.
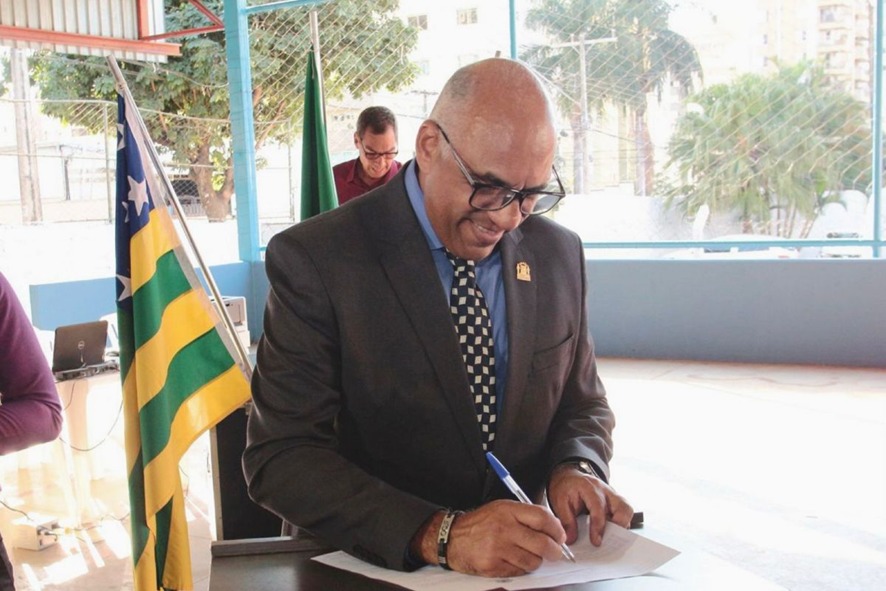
[444, 250, 496, 451]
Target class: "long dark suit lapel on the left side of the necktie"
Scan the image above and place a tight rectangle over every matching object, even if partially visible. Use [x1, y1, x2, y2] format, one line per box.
[363, 179, 485, 470]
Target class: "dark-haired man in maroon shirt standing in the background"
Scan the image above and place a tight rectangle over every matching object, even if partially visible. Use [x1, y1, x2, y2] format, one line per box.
[332, 107, 400, 205]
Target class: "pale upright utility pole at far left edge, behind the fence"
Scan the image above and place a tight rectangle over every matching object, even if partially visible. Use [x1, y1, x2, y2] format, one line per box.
[10, 49, 43, 224]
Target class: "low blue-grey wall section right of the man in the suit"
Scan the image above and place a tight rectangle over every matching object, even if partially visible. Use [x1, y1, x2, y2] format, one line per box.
[587, 259, 886, 367]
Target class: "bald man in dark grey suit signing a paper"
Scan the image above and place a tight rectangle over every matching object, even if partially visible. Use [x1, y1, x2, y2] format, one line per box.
[244, 59, 633, 576]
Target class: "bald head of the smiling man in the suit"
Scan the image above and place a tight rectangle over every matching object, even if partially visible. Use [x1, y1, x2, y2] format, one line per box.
[415, 58, 557, 261]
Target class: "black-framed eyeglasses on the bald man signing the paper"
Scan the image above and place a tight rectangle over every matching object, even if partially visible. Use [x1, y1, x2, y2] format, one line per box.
[434, 122, 566, 215]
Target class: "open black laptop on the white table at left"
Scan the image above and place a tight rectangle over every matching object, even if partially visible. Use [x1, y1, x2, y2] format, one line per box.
[52, 320, 117, 380]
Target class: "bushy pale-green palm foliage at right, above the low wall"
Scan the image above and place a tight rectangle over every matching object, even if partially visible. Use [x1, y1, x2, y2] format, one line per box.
[664, 63, 871, 238]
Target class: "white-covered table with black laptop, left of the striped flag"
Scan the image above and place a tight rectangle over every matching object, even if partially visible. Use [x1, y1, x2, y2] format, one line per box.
[52, 320, 126, 526]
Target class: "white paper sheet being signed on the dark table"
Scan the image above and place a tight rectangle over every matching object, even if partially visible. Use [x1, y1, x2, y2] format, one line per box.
[314, 520, 679, 591]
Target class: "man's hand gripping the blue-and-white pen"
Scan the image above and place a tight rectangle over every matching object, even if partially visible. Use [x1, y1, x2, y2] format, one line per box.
[447, 500, 566, 577]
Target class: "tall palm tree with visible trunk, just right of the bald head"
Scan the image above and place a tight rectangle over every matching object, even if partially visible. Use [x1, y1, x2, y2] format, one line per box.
[524, 0, 702, 195]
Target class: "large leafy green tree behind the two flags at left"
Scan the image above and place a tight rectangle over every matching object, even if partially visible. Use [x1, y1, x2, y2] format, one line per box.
[33, 0, 417, 219]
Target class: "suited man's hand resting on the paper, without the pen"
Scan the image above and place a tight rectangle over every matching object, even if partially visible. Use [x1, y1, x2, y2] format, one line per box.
[548, 464, 634, 546]
